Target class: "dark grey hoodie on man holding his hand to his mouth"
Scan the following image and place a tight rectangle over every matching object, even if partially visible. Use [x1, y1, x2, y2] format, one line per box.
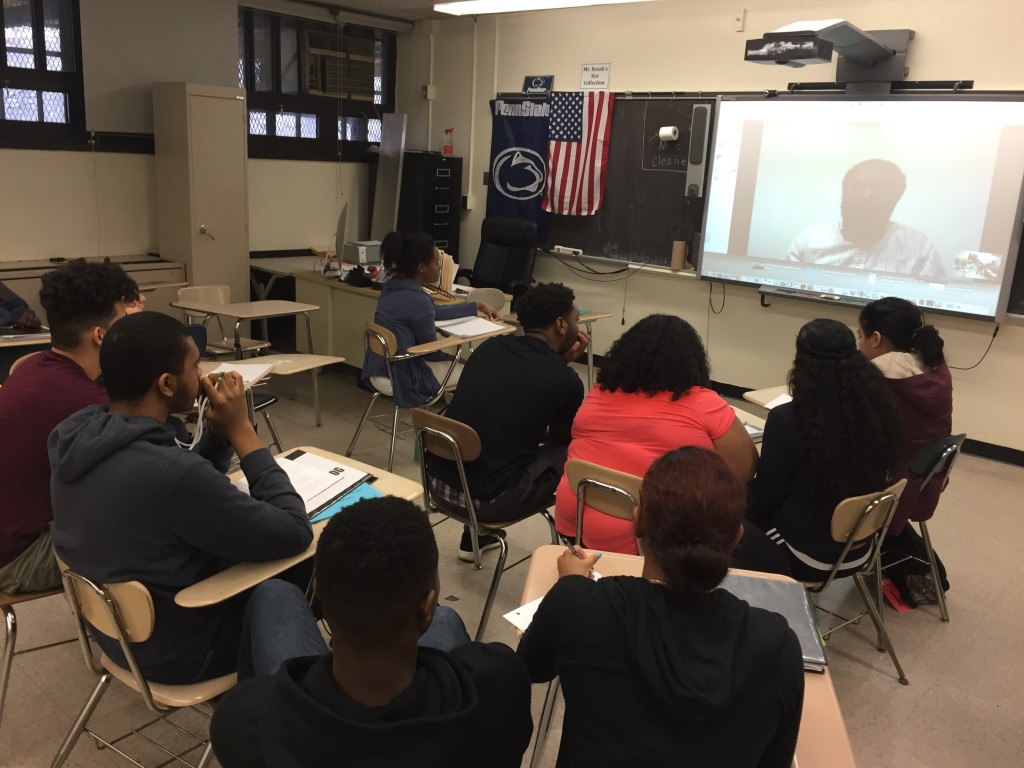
[47, 406, 312, 683]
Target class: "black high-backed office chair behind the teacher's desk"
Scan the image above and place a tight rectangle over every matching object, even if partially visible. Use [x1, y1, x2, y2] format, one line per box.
[456, 218, 538, 311]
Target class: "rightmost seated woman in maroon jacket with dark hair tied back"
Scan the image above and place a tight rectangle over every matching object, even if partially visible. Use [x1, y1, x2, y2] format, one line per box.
[857, 297, 953, 605]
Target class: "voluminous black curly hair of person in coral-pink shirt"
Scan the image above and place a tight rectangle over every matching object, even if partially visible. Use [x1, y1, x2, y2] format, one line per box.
[597, 314, 711, 400]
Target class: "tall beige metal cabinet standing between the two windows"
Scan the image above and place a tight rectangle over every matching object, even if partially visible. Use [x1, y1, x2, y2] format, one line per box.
[153, 83, 249, 301]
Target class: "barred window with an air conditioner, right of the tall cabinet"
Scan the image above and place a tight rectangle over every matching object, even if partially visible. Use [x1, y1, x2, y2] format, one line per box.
[239, 8, 395, 160]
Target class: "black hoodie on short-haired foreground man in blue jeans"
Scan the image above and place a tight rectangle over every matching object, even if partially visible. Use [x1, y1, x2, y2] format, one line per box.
[204, 643, 532, 768]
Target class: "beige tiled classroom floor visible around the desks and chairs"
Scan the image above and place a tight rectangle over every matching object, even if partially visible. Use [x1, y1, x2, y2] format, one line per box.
[0, 367, 1024, 768]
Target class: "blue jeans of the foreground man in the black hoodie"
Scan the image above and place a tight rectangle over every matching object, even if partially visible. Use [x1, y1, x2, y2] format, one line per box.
[239, 579, 469, 680]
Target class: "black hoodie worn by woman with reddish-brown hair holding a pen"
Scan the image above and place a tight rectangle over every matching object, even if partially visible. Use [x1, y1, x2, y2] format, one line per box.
[519, 577, 804, 768]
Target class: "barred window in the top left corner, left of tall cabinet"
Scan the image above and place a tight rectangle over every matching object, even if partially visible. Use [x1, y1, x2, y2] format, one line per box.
[0, 0, 85, 147]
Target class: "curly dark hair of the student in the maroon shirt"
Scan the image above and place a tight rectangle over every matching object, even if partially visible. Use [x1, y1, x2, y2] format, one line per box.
[39, 259, 138, 349]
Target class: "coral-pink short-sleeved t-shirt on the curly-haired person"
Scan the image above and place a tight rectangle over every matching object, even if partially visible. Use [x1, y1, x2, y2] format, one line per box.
[555, 387, 735, 555]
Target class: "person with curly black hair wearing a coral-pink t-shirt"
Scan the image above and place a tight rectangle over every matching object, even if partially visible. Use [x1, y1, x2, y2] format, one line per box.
[555, 314, 788, 574]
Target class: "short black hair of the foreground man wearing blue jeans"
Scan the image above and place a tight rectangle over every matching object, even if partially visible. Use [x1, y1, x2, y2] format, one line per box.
[314, 496, 437, 643]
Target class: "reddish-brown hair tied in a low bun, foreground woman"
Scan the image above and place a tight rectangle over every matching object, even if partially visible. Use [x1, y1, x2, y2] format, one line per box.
[637, 445, 746, 593]
